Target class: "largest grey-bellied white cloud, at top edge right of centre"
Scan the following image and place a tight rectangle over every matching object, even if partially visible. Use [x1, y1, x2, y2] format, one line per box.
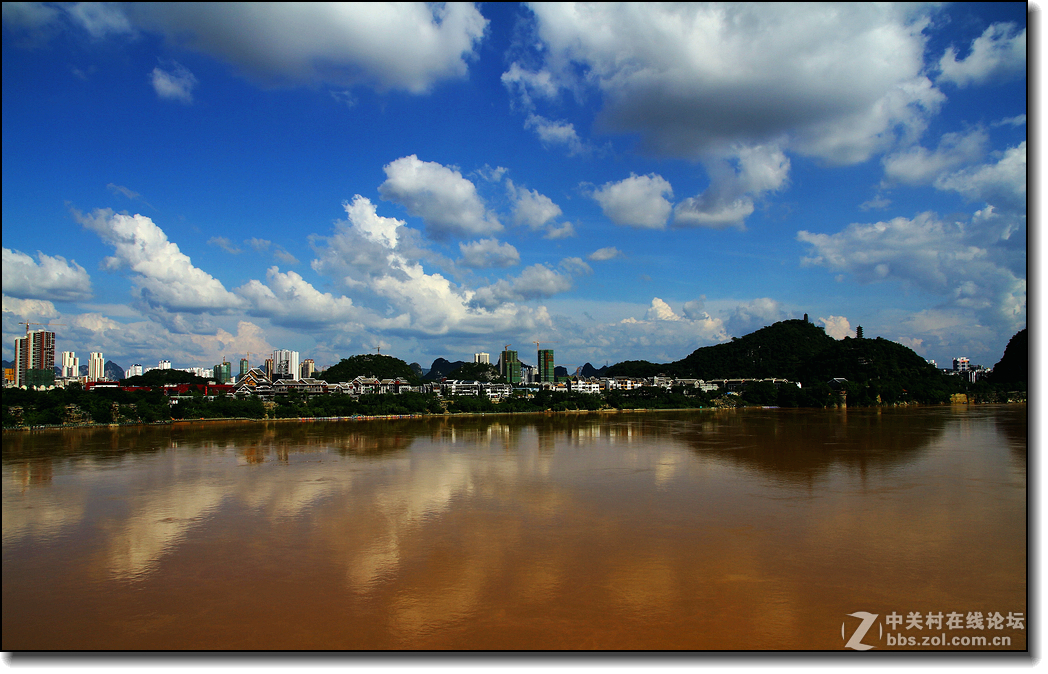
[524, 3, 942, 162]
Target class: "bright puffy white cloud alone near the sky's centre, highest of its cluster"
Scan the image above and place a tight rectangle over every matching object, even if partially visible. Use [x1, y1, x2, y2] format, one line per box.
[378, 155, 502, 239]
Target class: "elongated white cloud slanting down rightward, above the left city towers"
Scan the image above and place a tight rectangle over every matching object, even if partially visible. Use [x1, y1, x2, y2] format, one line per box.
[73, 209, 242, 313]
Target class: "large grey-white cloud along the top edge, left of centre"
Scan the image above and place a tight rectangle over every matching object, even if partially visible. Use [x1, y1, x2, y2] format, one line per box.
[128, 2, 487, 93]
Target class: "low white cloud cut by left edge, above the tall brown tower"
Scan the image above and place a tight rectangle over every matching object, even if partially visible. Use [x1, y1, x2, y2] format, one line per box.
[3, 247, 91, 302]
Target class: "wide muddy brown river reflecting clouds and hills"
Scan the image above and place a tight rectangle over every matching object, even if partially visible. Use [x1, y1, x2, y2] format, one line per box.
[2, 405, 1028, 651]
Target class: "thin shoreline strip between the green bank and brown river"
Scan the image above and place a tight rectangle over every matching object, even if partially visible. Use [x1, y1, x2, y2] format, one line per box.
[3, 400, 1027, 434]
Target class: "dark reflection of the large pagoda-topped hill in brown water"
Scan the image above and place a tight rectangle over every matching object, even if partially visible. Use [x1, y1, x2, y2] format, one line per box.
[678, 410, 947, 482]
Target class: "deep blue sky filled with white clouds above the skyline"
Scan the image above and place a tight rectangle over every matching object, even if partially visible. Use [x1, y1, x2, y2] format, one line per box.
[2, 3, 1027, 375]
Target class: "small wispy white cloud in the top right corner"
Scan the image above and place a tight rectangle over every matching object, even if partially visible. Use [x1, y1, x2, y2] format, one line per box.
[938, 23, 1026, 87]
